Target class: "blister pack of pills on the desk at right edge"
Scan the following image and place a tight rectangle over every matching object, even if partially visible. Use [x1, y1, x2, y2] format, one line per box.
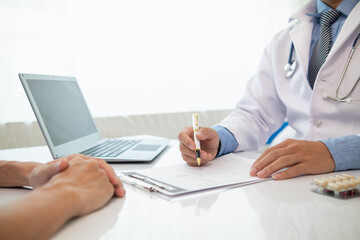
[313, 173, 360, 199]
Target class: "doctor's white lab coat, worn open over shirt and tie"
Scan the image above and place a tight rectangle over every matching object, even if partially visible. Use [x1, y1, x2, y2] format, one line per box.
[220, 1, 360, 151]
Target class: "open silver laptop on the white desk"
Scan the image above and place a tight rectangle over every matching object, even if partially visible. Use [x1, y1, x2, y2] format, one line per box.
[19, 73, 169, 162]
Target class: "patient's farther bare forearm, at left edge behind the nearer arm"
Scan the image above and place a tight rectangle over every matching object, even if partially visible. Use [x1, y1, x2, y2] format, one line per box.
[0, 160, 41, 187]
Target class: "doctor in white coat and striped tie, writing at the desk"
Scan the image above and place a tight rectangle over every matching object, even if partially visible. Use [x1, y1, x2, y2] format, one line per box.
[179, 0, 360, 179]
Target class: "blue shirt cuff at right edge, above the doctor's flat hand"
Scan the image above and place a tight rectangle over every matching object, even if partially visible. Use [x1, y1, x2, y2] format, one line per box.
[321, 135, 360, 171]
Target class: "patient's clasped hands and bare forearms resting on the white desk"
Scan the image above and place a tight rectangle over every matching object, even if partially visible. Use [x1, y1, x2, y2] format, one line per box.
[0, 154, 125, 239]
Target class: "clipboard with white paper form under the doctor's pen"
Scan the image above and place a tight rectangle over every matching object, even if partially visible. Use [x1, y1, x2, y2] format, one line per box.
[121, 153, 266, 195]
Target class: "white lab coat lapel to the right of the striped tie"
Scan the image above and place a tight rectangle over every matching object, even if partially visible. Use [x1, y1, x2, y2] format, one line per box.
[328, 2, 360, 58]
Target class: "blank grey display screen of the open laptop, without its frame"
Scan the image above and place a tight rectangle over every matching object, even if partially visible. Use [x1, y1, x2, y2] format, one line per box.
[27, 79, 97, 146]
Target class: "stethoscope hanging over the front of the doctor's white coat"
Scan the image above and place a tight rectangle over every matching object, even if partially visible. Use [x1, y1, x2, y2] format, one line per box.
[284, 34, 360, 103]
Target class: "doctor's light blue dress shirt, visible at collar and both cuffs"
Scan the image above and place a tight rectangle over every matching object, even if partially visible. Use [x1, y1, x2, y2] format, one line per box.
[212, 0, 360, 171]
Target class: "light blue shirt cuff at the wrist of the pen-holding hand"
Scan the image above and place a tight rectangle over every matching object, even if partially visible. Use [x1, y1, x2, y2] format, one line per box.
[212, 125, 239, 157]
